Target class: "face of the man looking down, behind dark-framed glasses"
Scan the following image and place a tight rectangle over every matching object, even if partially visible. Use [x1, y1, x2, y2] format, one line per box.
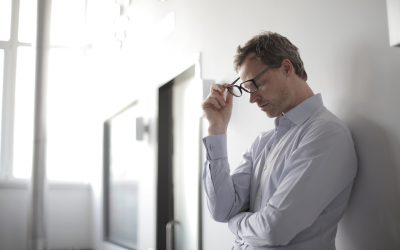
[239, 55, 293, 118]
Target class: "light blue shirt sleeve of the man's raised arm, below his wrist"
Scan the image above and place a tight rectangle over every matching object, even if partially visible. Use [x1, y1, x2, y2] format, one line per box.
[202, 135, 252, 222]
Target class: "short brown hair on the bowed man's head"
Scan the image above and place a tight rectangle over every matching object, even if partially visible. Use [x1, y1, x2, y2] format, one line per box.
[234, 31, 307, 80]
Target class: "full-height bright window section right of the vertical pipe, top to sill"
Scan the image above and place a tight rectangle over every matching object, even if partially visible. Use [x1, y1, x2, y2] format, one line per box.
[46, 0, 91, 182]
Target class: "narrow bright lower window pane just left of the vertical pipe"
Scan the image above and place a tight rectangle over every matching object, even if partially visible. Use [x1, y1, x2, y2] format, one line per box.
[13, 47, 35, 178]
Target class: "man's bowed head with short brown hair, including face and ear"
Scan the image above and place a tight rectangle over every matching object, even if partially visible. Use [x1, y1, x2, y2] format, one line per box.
[235, 32, 313, 117]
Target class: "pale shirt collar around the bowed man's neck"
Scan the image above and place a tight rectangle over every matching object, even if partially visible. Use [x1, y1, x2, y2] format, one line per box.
[278, 94, 324, 125]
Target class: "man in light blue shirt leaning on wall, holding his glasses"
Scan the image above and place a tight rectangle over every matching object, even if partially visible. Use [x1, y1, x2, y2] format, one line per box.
[202, 32, 357, 250]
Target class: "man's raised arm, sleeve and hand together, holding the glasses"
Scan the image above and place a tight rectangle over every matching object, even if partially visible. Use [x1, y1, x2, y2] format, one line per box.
[202, 84, 251, 222]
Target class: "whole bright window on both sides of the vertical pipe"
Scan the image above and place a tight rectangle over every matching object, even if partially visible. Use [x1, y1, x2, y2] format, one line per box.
[0, 0, 90, 181]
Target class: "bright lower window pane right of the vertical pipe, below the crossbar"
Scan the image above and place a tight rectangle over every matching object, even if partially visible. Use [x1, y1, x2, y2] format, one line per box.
[46, 49, 90, 182]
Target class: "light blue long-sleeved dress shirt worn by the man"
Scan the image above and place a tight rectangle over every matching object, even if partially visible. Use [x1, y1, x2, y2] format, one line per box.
[203, 94, 357, 250]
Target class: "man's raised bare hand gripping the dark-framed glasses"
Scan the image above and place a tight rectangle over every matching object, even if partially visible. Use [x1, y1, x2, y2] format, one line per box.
[202, 84, 233, 135]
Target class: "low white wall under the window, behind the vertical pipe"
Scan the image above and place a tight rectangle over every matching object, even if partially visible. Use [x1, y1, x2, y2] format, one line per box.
[0, 183, 93, 250]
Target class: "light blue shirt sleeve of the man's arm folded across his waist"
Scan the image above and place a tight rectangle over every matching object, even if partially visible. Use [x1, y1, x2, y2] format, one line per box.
[228, 122, 357, 246]
